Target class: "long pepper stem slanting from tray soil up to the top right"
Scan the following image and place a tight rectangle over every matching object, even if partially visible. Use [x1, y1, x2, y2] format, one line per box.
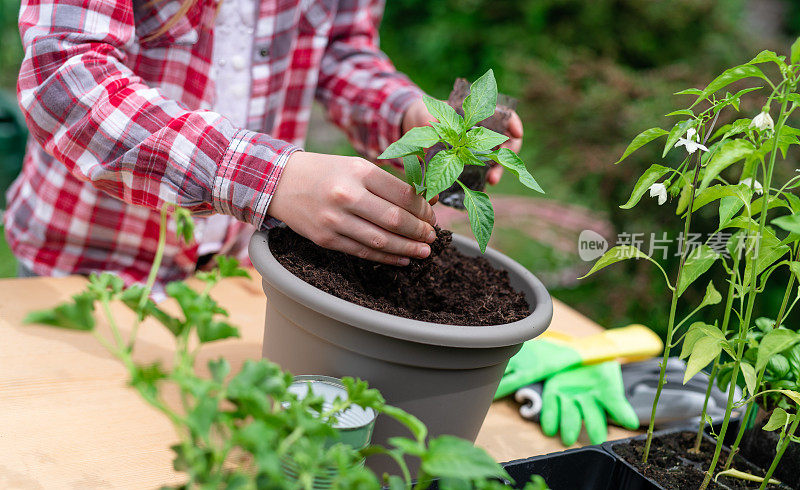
[700, 84, 788, 490]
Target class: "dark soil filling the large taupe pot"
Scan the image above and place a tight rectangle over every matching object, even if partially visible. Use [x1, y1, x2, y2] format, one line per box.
[269, 227, 530, 325]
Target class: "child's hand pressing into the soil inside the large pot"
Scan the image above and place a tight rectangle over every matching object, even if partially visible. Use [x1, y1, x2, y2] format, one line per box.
[267, 151, 436, 265]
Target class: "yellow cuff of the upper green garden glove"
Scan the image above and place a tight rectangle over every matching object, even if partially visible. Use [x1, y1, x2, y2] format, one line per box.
[542, 325, 664, 364]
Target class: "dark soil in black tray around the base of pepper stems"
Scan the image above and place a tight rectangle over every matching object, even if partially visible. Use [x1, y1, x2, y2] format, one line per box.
[613, 432, 788, 490]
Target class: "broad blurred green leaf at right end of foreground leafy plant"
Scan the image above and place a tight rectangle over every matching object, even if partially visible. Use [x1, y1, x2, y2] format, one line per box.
[421, 435, 510, 480]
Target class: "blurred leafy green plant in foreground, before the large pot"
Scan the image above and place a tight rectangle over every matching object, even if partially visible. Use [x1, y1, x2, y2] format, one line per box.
[26, 206, 547, 490]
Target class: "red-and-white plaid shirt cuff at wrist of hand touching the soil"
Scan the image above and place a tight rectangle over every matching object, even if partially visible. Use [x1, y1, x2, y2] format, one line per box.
[212, 129, 300, 229]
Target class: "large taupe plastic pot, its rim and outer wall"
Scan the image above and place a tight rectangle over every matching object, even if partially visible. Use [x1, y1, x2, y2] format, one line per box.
[250, 232, 553, 468]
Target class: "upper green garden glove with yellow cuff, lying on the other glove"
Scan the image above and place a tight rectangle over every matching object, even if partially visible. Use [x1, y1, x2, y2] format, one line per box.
[494, 325, 664, 399]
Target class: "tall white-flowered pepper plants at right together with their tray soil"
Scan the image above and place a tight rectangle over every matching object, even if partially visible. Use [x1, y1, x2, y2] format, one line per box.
[590, 40, 800, 489]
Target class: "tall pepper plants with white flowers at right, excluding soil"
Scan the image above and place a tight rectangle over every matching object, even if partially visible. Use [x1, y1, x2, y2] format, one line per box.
[587, 40, 800, 489]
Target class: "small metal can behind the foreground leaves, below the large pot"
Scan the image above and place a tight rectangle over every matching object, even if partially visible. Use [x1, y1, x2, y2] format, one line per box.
[282, 375, 377, 490]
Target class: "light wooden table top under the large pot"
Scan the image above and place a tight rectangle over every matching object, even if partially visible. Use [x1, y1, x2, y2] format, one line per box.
[0, 273, 631, 490]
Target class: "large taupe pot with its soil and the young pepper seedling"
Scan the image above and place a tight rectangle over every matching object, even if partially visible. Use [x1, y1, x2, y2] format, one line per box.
[250, 70, 552, 464]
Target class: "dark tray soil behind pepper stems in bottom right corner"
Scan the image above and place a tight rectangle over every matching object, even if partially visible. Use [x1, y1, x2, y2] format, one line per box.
[739, 419, 800, 489]
